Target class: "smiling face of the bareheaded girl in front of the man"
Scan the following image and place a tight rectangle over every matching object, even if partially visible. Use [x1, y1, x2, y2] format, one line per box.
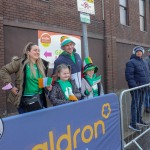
[58, 68, 70, 81]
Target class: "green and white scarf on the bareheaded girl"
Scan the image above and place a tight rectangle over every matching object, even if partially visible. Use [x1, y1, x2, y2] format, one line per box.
[57, 80, 72, 100]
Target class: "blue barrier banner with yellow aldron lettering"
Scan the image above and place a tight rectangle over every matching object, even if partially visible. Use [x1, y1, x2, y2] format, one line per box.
[0, 94, 121, 150]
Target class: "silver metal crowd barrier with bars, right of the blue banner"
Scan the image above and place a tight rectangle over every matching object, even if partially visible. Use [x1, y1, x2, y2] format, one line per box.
[120, 84, 150, 150]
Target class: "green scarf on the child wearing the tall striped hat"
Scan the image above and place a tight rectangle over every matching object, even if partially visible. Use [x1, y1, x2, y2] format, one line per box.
[85, 74, 101, 97]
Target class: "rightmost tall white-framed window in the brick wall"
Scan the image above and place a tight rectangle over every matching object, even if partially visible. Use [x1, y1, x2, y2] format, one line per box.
[139, 0, 146, 31]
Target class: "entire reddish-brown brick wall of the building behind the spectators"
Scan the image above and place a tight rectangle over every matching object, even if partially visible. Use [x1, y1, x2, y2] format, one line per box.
[0, 0, 150, 111]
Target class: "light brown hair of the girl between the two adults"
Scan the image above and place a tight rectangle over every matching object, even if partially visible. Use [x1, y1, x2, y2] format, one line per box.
[53, 64, 71, 81]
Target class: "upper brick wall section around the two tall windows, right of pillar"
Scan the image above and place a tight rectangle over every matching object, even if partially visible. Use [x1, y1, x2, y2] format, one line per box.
[116, 0, 150, 46]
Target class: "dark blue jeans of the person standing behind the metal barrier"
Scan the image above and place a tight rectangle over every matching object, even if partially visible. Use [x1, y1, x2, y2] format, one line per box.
[130, 89, 145, 126]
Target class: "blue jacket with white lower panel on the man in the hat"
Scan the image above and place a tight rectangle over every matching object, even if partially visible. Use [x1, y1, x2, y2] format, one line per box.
[53, 53, 82, 88]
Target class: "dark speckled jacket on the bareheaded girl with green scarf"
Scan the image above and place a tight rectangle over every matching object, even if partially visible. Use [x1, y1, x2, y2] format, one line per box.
[49, 80, 81, 106]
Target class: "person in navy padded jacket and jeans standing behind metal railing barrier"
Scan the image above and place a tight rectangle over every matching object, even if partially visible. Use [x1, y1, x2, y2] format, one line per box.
[125, 46, 150, 131]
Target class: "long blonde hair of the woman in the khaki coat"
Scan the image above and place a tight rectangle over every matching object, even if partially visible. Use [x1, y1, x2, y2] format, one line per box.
[23, 42, 45, 77]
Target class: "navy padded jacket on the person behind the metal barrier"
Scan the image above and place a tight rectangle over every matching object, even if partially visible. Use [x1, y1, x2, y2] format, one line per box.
[125, 55, 150, 88]
